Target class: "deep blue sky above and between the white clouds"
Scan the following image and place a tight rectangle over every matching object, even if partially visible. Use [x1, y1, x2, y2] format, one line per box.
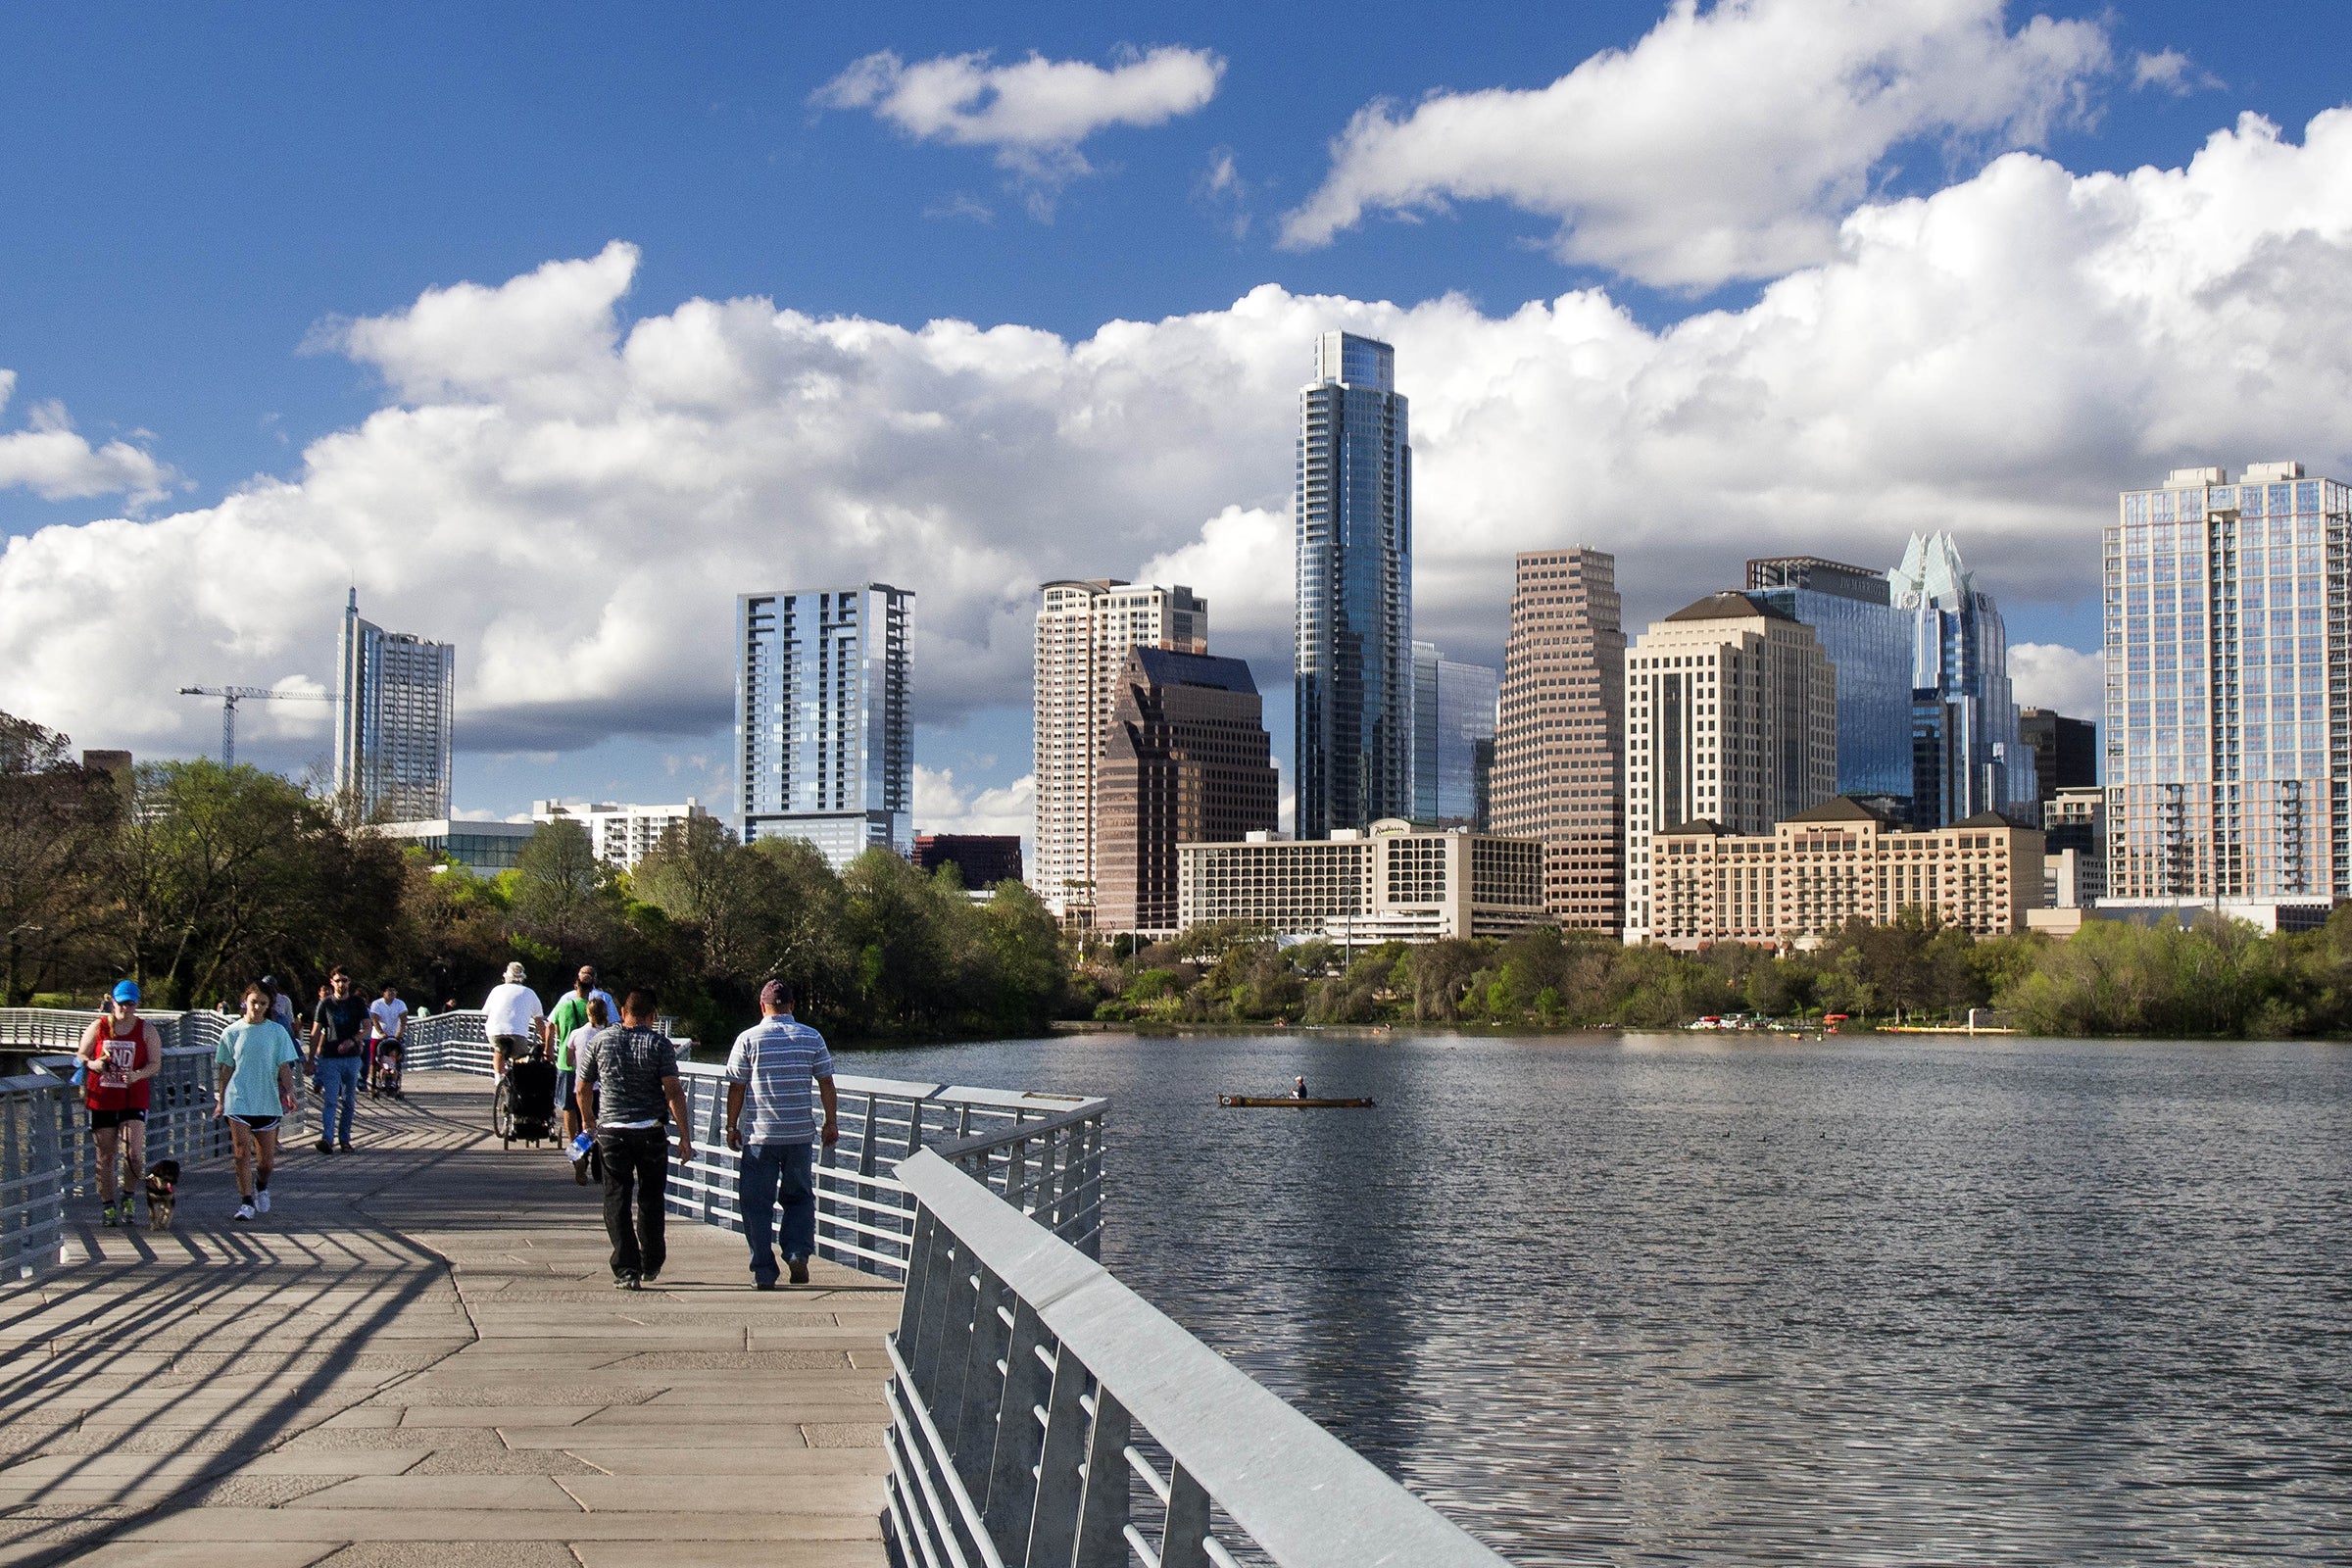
[0, 0, 2352, 832]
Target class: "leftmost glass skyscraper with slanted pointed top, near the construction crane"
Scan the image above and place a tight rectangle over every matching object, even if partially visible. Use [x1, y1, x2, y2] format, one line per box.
[334, 588, 457, 823]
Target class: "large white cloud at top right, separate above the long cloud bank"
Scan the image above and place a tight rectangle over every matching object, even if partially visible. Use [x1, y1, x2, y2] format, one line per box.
[1282, 0, 2110, 287]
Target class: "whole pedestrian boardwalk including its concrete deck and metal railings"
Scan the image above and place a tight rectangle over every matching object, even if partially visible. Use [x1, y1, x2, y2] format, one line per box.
[0, 1010, 1500, 1568]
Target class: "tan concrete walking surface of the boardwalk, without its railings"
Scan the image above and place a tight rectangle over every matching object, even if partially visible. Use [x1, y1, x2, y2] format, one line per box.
[0, 1074, 899, 1568]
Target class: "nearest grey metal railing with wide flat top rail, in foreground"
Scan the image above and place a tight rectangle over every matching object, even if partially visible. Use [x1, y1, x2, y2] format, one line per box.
[882, 1140, 1503, 1568]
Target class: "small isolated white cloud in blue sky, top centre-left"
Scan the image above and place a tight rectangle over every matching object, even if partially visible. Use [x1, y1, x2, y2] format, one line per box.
[809, 47, 1225, 178]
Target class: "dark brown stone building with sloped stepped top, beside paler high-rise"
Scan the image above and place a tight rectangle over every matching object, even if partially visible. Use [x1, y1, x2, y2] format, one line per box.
[1094, 649, 1280, 933]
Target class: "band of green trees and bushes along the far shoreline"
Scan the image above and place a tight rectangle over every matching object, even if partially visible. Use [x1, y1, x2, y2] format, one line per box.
[14, 714, 2352, 1046]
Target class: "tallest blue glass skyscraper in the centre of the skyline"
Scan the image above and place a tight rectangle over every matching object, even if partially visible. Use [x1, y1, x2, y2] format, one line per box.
[1292, 331, 1413, 839]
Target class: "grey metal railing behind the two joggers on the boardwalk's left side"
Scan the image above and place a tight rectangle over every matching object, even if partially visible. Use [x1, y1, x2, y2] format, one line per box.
[0, 1008, 248, 1284]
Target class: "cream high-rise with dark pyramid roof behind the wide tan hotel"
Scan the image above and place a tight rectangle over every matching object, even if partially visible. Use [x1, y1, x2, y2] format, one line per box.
[1625, 592, 1837, 943]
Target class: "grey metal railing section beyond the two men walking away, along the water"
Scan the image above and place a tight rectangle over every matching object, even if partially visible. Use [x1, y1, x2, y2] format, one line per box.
[402, 1010, 1107, 1279]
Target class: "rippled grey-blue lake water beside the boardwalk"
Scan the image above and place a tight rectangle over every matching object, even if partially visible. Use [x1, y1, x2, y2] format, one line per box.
[842, 1034, 2352, 1566]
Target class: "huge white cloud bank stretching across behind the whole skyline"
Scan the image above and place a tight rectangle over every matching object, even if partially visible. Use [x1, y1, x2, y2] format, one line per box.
[14, 111, 2352, 780]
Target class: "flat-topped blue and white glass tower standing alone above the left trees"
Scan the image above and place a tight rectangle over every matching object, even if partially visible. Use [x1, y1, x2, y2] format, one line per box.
[736, 583, 915, 870]
